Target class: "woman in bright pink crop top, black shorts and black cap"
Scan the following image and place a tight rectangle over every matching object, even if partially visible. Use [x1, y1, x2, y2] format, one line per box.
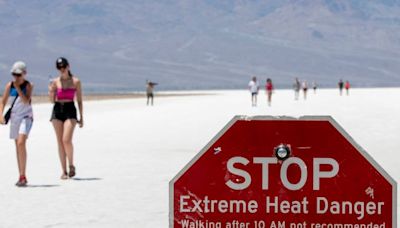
[49, 57, 83, 180]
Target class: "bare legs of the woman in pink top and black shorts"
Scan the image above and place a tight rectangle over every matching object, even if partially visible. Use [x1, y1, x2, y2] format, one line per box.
[52, 119, 76, 179]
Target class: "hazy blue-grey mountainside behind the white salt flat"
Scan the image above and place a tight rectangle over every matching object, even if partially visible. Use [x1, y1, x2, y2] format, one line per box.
[0, 0, 400, 92]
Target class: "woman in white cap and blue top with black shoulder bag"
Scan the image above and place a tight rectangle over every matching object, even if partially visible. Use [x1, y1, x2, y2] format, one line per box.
[0, 61, 33, 187]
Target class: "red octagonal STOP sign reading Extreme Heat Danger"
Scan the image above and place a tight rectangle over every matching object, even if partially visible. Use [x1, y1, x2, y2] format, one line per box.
[170, 116, 397, 228]
